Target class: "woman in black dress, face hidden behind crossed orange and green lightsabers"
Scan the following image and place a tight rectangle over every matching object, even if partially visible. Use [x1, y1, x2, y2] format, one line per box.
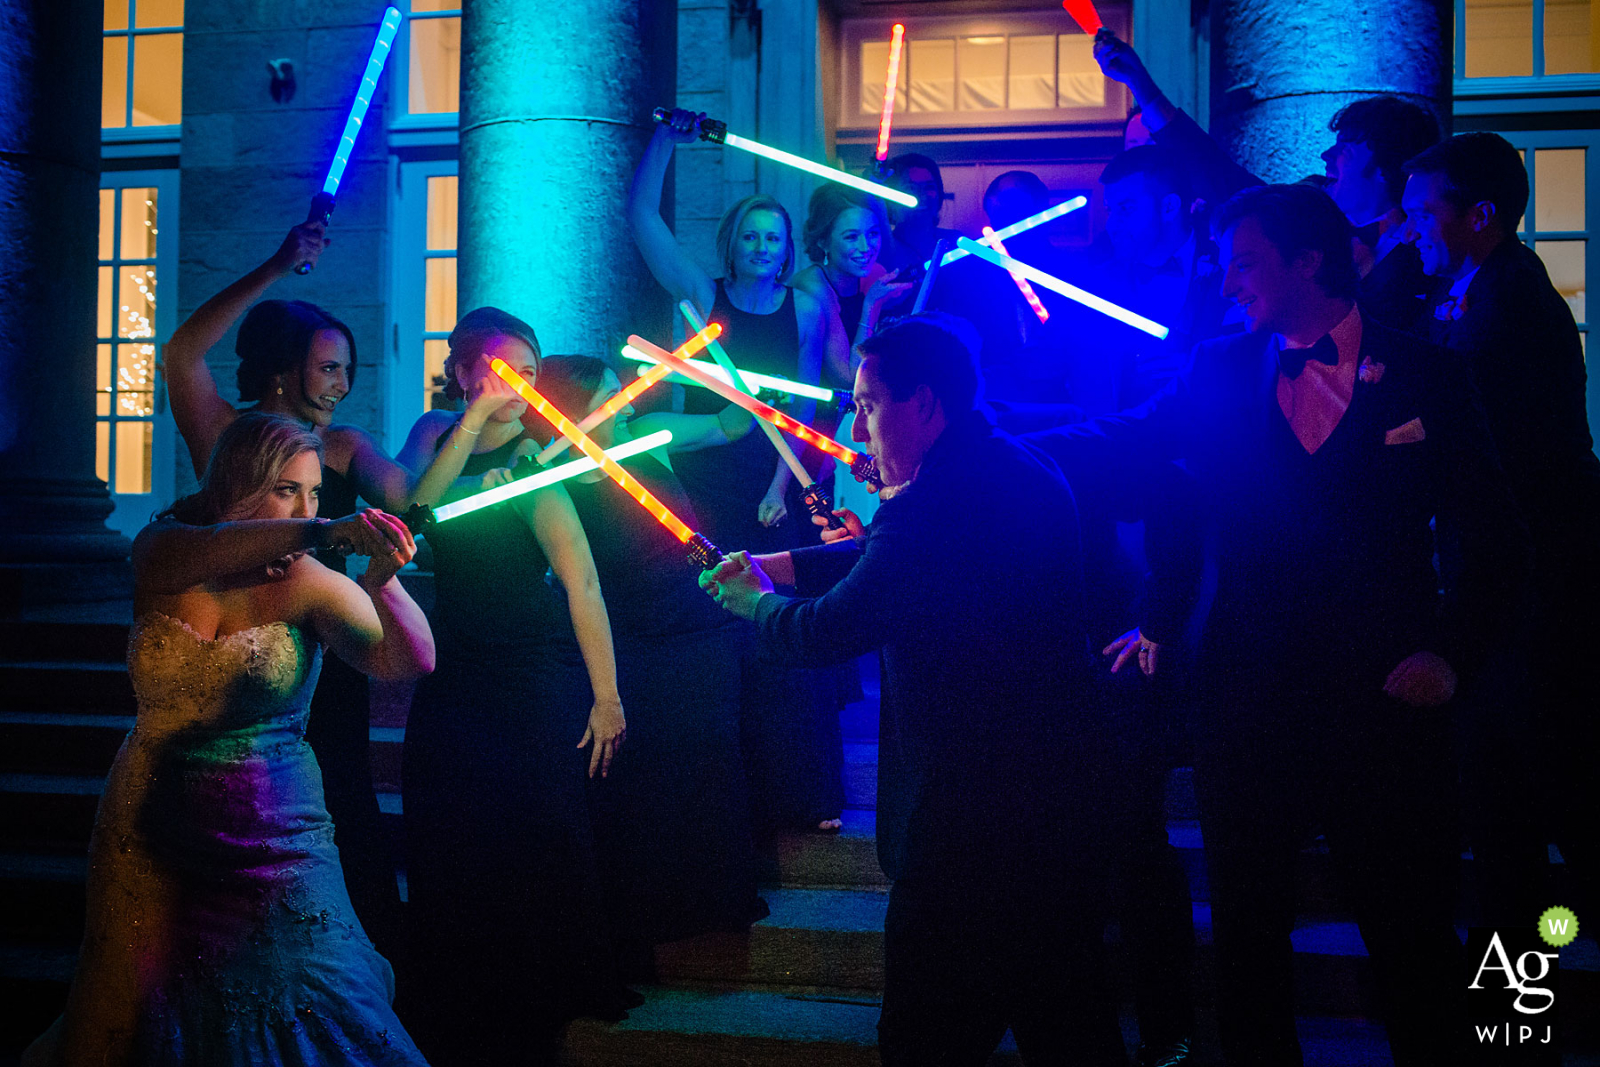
[539, 357, 765, 958]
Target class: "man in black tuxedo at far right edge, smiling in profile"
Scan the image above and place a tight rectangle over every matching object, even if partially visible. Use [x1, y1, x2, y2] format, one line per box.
[1405, 133, 1600, 925]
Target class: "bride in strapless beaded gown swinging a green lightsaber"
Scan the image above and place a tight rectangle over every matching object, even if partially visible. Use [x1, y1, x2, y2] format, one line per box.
[22, 414, 434, 1067]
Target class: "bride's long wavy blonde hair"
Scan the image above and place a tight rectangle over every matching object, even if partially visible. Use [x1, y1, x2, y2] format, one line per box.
[158, 411, 322, 526]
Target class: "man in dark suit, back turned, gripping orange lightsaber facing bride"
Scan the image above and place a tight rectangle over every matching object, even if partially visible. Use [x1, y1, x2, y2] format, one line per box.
[701, 314, 1126, 1067]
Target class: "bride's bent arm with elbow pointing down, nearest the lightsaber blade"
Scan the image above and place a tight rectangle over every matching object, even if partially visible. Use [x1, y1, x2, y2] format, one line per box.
[300, 509, 434, 681]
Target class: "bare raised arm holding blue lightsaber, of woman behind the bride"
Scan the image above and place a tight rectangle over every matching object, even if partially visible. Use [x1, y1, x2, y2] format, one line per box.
[162, 222, 328, 475]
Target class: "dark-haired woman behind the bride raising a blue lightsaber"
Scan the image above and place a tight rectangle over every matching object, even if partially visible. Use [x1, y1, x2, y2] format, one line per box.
[162, 222, 510, 969]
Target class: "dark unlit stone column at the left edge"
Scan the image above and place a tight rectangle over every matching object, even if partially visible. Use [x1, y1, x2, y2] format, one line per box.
[0, 0, 131, 613]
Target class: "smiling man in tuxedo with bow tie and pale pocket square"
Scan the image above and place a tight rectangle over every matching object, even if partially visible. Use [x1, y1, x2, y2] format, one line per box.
[1029, 186, 1522, 1067]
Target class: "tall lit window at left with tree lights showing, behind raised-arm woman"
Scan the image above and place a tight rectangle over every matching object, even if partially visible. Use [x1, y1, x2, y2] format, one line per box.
[94, 186, 163, 493]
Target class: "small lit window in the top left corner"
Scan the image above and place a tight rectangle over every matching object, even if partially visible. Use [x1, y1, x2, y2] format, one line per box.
[101, 0, 184, 130]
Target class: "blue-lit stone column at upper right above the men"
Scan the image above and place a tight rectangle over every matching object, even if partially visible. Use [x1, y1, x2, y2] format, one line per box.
[1211, 0, 1453, 182]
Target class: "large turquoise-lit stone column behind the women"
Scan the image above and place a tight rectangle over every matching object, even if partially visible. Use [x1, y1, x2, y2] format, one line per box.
[456, 0, 677, 363]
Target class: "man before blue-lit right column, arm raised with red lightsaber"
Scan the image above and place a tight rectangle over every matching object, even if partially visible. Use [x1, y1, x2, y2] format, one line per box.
[1094, 32, 1438, 330]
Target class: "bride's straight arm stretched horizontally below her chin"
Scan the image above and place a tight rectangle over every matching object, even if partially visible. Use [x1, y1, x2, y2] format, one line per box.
[133, 515, 379, 597]
